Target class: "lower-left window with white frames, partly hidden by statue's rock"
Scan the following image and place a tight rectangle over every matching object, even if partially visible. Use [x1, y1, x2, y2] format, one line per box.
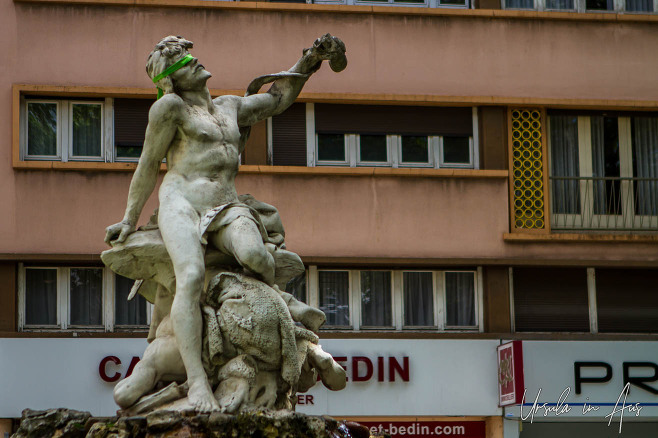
[18, 266, 150, 331]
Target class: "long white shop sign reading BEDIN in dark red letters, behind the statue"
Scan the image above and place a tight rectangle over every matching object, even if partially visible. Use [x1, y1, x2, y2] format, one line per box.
[0, 338, 498, 418]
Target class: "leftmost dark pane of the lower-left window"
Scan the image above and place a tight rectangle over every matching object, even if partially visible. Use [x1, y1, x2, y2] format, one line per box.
[25, 268, 57, 325]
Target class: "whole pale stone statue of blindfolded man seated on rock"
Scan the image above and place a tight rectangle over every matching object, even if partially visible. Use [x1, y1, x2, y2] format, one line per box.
[101, 34, 347, 413]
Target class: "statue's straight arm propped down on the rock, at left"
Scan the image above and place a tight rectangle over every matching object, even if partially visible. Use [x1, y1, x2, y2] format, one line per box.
[105, 93, 183, 244]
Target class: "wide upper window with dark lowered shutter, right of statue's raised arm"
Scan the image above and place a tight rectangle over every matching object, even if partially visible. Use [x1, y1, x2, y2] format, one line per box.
[268, 103, 479, 169]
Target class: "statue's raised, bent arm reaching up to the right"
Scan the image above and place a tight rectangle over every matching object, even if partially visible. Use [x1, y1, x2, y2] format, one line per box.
[232, 34, 347, 127]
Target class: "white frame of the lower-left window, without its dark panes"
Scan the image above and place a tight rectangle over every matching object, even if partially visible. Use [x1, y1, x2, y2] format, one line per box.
[18, 263, 153, 332]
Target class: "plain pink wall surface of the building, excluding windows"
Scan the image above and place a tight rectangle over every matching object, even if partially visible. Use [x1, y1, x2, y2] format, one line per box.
[0, 0, 658, 265]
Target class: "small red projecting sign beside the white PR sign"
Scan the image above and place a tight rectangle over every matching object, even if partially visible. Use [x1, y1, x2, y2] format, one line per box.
[496, 341, 524, 406]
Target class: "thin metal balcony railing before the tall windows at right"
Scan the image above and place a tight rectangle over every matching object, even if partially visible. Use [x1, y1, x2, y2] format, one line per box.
[549, 176, 658, 231]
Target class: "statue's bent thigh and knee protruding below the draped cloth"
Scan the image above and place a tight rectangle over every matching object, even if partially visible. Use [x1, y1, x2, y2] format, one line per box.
[210, 217, 274, 286]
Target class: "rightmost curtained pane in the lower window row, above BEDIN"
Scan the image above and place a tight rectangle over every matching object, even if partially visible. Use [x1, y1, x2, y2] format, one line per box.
[445, 272, 475, 327]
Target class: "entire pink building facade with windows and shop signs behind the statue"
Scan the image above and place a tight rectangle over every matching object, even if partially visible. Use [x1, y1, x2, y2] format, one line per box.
[0, 0, 658, 438]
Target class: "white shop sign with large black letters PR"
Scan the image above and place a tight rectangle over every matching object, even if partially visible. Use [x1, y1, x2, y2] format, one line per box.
[505, 341, 658, 420]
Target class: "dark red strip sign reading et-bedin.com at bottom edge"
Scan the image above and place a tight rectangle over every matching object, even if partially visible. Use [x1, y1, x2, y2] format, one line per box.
[359, 421, 486, 438]
